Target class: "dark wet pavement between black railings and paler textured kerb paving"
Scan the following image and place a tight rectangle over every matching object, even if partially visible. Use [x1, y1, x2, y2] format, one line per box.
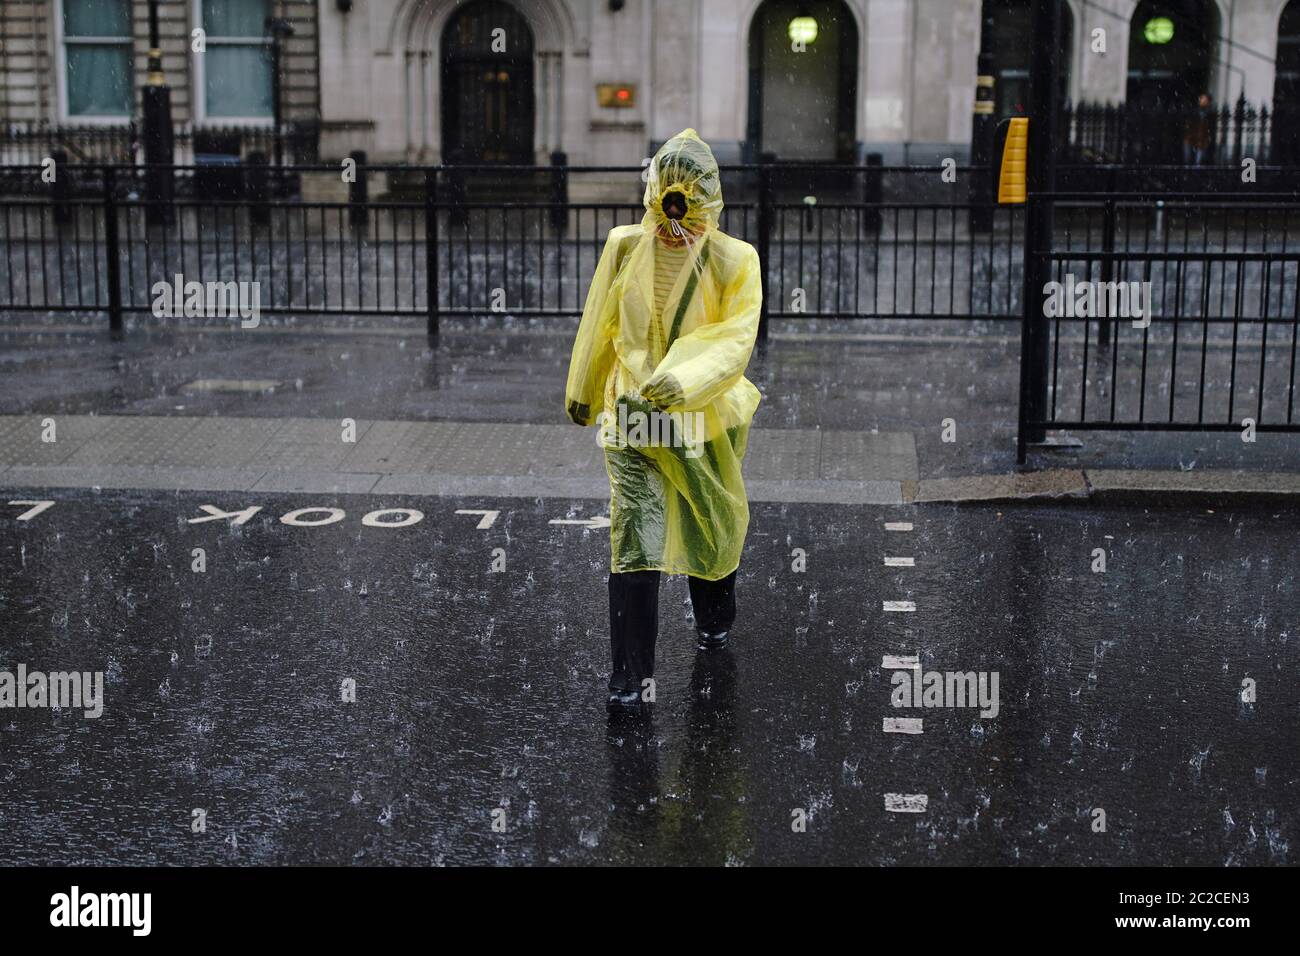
[0, 316, 1300, 477]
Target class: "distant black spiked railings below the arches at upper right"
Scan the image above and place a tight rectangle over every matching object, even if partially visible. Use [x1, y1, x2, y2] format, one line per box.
[1061, 100, 1300, 166]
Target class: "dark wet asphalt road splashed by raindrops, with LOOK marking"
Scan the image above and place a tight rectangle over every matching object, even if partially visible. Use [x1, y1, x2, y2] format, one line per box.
[0, 489, 1300, 865]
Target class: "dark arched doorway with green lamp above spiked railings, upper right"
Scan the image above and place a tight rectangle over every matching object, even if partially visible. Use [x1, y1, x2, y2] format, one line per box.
[1125, 0, 1219, 111]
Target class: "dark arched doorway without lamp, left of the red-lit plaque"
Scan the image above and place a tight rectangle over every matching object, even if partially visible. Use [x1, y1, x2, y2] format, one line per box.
[441, 0, 536, 163]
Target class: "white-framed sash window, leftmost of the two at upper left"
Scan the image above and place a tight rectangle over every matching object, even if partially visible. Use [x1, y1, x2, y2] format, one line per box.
[61, 0, 133, 117]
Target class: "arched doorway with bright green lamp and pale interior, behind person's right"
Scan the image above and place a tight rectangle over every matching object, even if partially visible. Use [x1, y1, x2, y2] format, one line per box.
[745, 0, 858, 163]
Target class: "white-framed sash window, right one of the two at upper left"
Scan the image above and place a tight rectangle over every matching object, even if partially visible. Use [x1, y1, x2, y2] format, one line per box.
[202, 0, 272, 120]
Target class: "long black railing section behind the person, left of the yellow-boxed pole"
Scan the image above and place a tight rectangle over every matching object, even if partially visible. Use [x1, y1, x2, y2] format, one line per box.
[0, 160, 1023, 332]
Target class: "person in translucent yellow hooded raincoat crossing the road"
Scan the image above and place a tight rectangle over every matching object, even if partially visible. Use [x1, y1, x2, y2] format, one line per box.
[566, 129, 763, 714]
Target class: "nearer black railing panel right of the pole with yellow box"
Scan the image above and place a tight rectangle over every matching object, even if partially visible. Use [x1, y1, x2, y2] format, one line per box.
[1019, 194, 1300, 462]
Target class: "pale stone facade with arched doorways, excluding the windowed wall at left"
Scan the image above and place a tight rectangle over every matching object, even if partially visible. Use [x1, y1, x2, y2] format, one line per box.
[320, 0, 1300, 164]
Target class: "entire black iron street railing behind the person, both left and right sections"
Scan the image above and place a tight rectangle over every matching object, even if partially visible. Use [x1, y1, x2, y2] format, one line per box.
[0, 164, 1300, 460]
